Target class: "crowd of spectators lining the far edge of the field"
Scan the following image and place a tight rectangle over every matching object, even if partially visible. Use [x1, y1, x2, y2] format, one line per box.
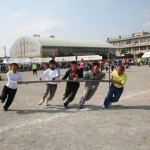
[0, 57, 150, 72]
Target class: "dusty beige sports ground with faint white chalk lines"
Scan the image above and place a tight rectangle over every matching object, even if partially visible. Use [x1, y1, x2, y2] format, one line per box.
[0, 66, 150, 150]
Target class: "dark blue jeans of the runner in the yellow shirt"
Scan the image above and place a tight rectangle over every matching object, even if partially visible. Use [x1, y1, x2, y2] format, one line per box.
[104, 84, 124, 108]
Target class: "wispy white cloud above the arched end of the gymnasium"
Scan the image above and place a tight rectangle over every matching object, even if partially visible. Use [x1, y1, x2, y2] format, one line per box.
[12, 20, 66, 35]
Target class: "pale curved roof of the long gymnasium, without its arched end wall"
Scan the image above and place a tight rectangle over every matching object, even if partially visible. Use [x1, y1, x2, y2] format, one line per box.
[33, 36, 116, 48]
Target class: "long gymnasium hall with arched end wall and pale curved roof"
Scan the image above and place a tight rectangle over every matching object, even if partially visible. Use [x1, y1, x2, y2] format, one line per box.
[10, 35, 116, 58]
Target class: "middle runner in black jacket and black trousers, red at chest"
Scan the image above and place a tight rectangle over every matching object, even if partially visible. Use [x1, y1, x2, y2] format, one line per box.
[62, 61, 82, 108]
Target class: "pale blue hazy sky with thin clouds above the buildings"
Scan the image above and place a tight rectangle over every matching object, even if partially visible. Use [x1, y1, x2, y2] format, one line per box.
[0, 0, 150, 57]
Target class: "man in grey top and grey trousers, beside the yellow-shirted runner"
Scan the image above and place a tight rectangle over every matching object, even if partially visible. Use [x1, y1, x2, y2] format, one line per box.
[79, 63, 105, 109]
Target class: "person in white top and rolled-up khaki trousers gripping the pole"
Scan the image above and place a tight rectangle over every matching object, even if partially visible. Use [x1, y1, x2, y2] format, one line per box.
[39, 60, 60, 106]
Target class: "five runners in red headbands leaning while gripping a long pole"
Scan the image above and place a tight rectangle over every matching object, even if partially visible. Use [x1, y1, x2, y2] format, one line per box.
[0, 60, 127, 111]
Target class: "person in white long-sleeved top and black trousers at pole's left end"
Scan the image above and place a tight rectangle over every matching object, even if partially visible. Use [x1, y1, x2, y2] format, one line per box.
[0, 63, 23, 111]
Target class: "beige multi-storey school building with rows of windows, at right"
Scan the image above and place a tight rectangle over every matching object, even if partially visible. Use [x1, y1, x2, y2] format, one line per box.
[107, 31, 150, 56]
